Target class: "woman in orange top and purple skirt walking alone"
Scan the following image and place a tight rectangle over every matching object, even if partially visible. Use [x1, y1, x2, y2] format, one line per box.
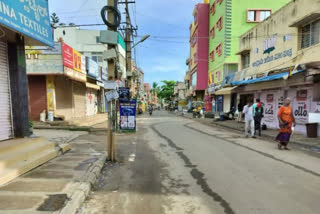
[276, 98, 296, 150]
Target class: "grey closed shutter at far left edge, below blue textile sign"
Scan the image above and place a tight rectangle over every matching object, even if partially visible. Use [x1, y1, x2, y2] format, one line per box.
[0, 41, 13, 141]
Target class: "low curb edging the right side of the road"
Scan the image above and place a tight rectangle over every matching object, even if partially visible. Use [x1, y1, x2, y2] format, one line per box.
[179, 115, 320, 154]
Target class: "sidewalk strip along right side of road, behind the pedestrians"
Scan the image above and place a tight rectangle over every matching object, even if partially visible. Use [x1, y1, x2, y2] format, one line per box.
[183, 113, 320, 152]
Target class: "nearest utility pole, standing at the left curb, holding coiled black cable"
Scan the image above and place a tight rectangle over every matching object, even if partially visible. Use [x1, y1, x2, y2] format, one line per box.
[107, 0, 117, 162]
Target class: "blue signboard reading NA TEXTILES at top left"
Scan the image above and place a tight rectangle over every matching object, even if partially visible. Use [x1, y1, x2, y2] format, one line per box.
[0, 0, 54, 47]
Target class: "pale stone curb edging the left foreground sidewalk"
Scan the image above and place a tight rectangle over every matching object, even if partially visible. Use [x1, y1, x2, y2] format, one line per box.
[54, 153, 107, 214]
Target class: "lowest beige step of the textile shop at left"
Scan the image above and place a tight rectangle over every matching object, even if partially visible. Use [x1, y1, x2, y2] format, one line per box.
[0, 149, 57, 185]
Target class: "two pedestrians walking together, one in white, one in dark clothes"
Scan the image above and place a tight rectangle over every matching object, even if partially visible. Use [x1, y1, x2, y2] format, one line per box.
[242, 99, 264, 138]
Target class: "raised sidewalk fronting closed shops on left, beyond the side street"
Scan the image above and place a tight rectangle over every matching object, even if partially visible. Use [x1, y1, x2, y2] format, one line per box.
[34, 114, 108, 131]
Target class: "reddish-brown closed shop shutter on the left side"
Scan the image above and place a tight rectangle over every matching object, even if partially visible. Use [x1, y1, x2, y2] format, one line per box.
[28, 76, 47, 121]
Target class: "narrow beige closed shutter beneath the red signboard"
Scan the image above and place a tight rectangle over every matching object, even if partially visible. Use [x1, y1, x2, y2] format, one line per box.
[73, 81, 86, 118]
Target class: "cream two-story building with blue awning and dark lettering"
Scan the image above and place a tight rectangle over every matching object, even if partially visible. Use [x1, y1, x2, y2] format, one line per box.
[232, 0, 320, 132]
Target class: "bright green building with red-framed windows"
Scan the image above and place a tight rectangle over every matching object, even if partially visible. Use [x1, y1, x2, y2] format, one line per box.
[209, 0, 291, 88]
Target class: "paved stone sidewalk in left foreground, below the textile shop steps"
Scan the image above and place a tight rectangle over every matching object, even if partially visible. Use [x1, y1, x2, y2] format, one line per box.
[0, 130, 107, 214]
